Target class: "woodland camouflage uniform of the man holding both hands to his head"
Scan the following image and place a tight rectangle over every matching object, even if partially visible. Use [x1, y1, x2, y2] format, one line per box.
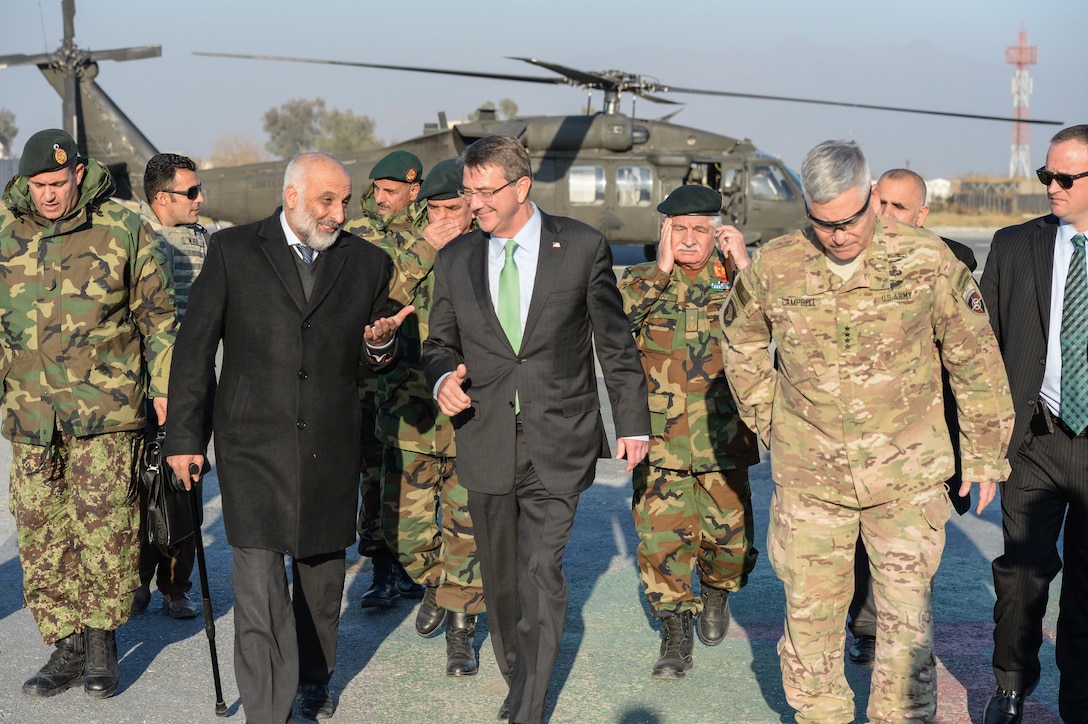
[619, 253, 759, 616]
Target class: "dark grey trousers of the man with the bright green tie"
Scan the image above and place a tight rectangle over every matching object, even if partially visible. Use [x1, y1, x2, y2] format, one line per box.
[469, 426, 578, 724]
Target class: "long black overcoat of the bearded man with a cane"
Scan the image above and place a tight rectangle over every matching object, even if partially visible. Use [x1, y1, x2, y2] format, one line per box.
[165, 211, 391, 557]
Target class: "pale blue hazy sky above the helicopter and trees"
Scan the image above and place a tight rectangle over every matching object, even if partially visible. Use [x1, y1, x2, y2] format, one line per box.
[0, 0, 1088, 177]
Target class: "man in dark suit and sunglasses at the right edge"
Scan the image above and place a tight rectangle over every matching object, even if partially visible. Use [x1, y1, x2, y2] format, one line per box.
[981, 124, 1088, 724]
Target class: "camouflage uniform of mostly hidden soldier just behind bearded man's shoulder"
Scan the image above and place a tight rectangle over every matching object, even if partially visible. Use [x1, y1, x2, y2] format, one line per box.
[344, 184, 426, 557]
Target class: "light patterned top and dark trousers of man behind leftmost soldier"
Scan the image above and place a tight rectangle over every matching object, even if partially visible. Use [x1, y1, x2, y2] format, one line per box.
[139, 201, 208, 594]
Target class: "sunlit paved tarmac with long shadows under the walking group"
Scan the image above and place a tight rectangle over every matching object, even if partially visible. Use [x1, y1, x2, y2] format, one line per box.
[0, 228, 1061, 724]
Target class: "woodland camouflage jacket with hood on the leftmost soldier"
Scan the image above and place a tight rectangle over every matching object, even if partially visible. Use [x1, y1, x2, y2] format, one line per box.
[0, 159, 175, 446]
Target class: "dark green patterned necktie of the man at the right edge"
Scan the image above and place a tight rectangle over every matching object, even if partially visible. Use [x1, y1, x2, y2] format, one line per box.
[1061, 234, 1088, 434]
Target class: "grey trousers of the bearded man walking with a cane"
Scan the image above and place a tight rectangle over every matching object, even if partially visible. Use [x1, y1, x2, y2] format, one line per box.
[233, 548, 345, 724]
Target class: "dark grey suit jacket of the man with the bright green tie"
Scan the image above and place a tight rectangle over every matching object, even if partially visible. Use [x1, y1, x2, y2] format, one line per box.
[423, 205, 650, 494]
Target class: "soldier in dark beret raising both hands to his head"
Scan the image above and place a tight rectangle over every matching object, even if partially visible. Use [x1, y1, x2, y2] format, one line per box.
[619, 185, 759, 678]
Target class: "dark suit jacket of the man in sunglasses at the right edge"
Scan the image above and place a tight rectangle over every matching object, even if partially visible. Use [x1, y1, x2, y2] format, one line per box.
[979, 216, 1059, 457]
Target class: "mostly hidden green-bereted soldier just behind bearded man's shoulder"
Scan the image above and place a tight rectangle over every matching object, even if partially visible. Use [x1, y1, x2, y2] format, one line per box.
[344, 150, 426, 609]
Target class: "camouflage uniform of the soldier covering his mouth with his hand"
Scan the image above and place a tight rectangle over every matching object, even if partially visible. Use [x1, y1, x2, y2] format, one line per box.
[350, 189, 484, 614]
